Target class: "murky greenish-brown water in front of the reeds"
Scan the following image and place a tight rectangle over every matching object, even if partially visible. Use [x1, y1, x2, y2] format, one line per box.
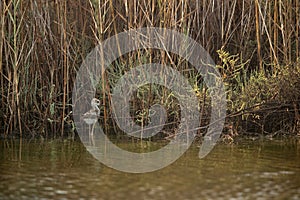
[0, 138, 300, 200]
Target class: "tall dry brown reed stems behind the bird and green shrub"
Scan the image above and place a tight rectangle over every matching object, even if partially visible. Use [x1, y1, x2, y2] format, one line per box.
[0, 0, 300, 136]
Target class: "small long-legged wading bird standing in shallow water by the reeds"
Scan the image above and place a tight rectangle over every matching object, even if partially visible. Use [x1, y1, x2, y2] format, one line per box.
[82, 98, 100, 142]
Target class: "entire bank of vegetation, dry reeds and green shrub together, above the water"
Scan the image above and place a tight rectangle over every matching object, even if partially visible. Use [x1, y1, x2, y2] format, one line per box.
[0, 0, 300, 137]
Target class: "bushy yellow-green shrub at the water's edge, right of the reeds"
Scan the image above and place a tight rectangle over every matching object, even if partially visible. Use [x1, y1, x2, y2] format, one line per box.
[218, 48, 300, 133]
